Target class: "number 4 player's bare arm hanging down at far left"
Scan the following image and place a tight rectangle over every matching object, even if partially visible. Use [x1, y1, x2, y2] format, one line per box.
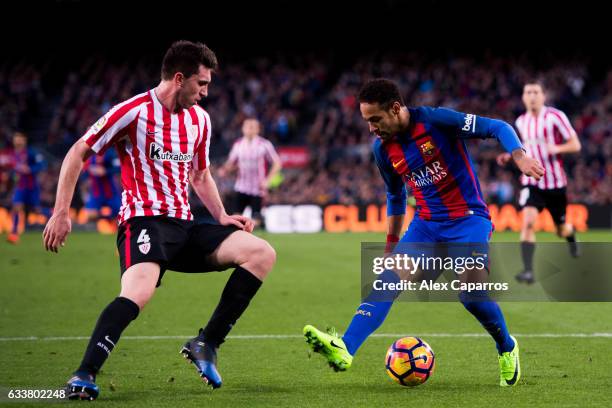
[43, 139, 93, 252]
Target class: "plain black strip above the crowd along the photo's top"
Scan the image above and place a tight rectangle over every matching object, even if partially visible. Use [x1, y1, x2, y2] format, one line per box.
[0, 0, 610, 63]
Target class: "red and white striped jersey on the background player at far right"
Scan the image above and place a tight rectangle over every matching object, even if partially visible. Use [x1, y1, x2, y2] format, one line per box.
[516, 106, 575, 190]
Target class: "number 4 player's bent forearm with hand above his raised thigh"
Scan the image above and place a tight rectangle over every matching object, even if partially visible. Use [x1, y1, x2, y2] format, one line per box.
[189, 168, 254, 232]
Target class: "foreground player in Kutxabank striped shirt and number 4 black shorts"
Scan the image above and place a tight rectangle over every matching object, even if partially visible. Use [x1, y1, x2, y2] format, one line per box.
[43, 41, 276, 400]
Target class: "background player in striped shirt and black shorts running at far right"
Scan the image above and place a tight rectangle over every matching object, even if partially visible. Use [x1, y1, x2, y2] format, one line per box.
[497, 80, 581, 283]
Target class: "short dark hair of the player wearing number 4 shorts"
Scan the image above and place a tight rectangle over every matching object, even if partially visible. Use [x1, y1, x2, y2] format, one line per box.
[162, 40, 219, 80]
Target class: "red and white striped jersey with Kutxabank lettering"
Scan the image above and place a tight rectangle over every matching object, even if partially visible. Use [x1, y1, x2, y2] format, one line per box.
[83, 89, 211, 224]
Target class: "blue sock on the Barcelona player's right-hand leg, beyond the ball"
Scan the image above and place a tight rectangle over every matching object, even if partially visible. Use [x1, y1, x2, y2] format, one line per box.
[459, 290, 514, 354]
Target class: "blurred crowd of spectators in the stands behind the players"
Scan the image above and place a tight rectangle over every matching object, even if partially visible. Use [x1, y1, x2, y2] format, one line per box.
[0, 53, 612, 212]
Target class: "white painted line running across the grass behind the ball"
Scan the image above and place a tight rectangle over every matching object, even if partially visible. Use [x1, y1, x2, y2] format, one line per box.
[0, 333, 612, 342]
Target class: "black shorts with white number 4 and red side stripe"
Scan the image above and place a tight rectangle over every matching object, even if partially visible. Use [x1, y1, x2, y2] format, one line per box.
[117, 215, 238, 286]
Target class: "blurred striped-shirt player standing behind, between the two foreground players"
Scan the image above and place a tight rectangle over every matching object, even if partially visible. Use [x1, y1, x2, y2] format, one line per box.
[220, 118, 282, 225]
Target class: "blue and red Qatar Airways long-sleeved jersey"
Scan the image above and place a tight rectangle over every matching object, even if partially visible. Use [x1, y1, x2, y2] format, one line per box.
[373, 107, 522, 221]
